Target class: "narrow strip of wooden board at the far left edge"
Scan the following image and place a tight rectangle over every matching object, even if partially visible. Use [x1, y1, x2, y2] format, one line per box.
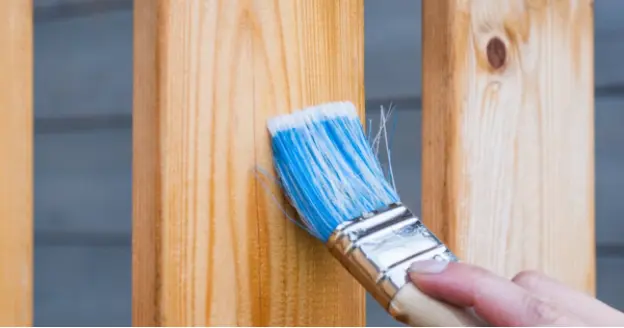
[0, 0, 33, 326]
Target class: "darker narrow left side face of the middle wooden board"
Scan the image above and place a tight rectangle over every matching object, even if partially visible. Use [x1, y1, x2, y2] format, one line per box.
[132, 1, 163, 327]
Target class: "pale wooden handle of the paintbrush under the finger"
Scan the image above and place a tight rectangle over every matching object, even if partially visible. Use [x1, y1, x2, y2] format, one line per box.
[389, 283, 487, 327]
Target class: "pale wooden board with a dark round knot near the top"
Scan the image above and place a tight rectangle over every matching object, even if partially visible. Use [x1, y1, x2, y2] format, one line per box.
[423, 0, 595, 293]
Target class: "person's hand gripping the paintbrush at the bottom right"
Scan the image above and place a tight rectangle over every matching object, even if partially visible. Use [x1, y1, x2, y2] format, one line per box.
[409, 260, 624, 327]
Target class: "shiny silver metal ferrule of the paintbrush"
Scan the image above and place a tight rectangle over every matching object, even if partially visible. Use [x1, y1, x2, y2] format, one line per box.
[327, 203, 457, 309]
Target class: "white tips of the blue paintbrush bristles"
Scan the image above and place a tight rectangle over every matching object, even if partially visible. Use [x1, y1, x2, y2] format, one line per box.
[267, 101, 358, 135]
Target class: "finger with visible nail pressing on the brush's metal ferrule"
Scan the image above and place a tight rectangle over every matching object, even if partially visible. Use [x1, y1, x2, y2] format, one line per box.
[409, 261, 581, 327]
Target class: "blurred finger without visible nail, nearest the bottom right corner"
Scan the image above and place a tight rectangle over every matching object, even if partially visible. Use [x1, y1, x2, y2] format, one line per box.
[511, 271, 624, 326]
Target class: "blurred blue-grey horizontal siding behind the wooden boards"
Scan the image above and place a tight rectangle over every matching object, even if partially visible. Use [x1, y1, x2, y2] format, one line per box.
[35, 0, 624, 326]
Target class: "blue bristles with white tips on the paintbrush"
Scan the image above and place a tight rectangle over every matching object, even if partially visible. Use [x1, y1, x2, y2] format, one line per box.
[268, 102, 399, 242]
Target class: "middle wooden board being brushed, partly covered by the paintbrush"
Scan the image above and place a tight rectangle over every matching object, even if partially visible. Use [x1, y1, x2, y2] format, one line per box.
[133, 0, 364, 326]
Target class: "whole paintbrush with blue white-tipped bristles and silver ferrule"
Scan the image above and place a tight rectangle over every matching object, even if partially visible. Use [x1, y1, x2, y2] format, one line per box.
[267, 102, 483, 327]
